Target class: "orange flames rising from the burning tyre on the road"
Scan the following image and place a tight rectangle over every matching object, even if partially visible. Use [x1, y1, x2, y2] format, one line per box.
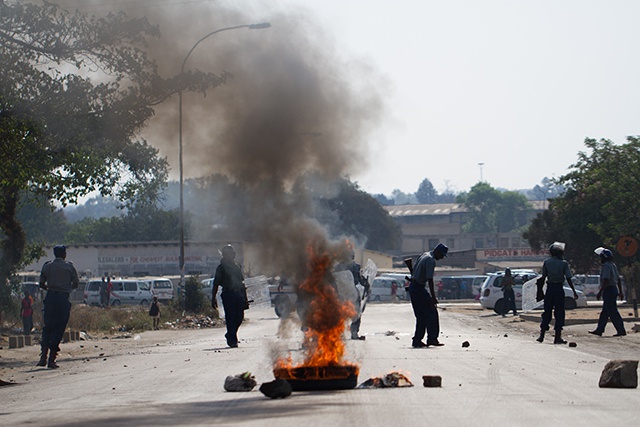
[274, 241, 358, 379]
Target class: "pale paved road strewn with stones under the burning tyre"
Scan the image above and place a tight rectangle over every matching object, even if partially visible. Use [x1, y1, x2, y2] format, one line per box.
[0, 304, 640, 427]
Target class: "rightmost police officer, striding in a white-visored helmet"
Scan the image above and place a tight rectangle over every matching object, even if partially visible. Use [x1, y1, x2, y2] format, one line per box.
[589, 248, 627, 337]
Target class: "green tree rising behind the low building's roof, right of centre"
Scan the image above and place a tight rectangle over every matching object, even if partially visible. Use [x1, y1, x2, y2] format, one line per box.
[457, 182, 528, 233]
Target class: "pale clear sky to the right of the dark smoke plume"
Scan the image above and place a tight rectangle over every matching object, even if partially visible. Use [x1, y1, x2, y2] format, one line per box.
[269, 0, 640, 194]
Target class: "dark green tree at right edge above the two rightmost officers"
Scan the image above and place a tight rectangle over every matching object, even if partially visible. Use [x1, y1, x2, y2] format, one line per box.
[525, 136, 640, 272]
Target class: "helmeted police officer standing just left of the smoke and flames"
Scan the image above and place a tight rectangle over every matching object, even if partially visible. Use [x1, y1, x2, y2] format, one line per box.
[211, 245, 249, 348]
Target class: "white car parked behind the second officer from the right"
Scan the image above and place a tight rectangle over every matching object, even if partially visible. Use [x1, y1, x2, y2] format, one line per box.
[480, 270, 587, 313]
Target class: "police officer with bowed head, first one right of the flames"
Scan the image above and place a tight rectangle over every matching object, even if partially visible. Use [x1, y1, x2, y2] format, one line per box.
[409, 243, 449, 348]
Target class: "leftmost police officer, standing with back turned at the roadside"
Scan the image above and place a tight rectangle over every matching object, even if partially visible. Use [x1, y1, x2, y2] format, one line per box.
[37, 246, 79, 369]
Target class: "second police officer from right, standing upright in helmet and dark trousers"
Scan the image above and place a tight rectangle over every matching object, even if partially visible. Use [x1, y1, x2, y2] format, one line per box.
[536, 242, 578, 344]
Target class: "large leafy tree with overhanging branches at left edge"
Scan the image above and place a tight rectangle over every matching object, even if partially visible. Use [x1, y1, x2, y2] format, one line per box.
[0, 1, 226, 314]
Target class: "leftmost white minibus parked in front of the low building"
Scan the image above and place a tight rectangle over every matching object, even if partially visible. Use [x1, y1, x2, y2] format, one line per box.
[84, 279, 153, 307]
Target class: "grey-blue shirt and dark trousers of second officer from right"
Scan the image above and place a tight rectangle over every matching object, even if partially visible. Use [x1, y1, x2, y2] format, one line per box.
[540, 256, 571, 332]
